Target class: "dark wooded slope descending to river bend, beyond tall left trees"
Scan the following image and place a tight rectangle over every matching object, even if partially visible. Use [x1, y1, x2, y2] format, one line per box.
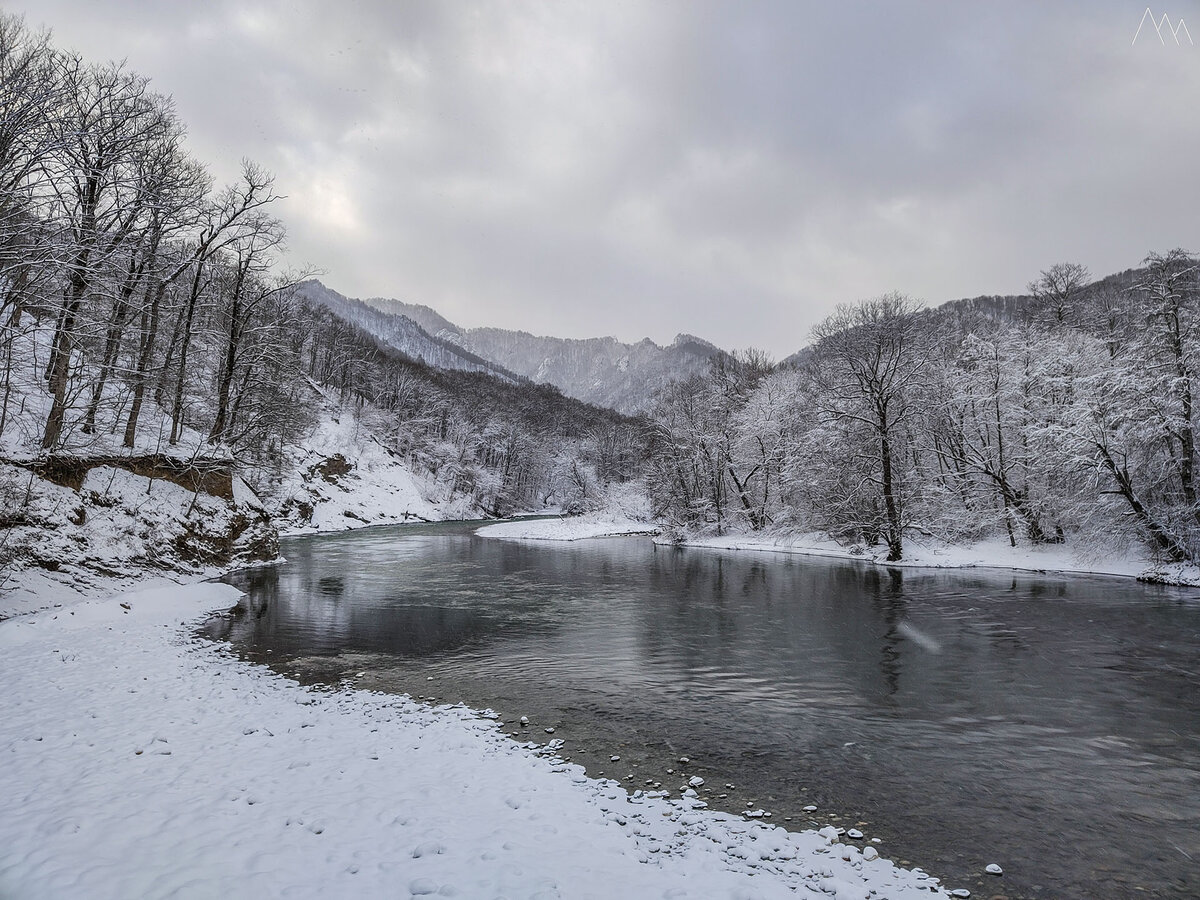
[286, 301, 643, 516]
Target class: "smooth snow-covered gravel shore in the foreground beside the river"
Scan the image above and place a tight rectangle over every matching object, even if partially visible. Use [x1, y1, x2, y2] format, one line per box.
[0, 584, 946, 900]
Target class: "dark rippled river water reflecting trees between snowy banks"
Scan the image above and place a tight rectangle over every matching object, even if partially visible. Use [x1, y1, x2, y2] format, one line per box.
[209, 524, 1200, 898]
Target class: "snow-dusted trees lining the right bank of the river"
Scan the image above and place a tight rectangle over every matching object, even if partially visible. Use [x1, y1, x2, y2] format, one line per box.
[649, 250, 1200, 562]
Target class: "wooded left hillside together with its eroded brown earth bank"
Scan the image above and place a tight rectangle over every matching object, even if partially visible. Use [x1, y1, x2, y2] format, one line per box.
[0, 16, 638, 592]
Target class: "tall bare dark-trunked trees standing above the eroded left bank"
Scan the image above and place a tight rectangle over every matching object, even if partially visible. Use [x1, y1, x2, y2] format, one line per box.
[0, 16, 309, 452]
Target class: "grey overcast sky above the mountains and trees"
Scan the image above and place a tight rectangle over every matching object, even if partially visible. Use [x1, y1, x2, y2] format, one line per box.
[18, 0, 1200, 356]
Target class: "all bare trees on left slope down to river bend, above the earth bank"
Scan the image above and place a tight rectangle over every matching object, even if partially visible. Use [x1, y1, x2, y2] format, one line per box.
[0, 14, 640, 515]
